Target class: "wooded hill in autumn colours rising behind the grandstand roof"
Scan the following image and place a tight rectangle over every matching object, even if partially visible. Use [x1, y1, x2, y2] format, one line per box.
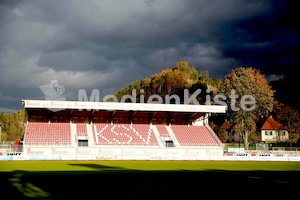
[114, 61, 221, 104]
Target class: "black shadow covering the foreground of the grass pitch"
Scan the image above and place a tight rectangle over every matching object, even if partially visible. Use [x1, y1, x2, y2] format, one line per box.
[0, 163, 300, 200]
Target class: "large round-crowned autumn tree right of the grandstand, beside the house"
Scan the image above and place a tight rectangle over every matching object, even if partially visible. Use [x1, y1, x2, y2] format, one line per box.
[219, 67, 275, 150]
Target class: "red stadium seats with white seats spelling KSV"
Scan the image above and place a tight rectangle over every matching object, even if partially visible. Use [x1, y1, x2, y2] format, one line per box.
[24, 122, 220, 146]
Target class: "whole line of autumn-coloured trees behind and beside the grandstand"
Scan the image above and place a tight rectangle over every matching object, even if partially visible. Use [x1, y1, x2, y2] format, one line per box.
[0, 61, 300, 149]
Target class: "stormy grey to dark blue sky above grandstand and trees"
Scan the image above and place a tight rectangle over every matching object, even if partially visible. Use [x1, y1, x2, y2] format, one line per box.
[0, 0, 300, 113]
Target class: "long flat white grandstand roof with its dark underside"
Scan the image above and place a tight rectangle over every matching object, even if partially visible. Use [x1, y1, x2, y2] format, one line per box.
[22, 100, 226, 121]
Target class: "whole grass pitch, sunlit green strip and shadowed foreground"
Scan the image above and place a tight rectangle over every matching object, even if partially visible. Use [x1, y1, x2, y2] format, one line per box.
[0, 160, 300, 199]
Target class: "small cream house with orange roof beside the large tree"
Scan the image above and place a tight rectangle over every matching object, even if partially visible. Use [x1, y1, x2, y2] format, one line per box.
[261, 116, 289, 143]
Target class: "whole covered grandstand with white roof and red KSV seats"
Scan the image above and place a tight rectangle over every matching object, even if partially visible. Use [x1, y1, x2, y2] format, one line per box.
[18, 100, 226, 160]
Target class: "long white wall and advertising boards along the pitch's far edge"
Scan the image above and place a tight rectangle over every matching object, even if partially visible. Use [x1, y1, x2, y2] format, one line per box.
[0, 147, 300, 162]
